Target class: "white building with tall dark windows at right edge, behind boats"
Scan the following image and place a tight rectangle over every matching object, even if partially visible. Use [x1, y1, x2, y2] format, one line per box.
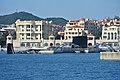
[101, 25, 120, 46]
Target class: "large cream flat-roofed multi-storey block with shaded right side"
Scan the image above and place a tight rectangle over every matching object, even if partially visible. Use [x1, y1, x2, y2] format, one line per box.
[15, 19, 52, 47]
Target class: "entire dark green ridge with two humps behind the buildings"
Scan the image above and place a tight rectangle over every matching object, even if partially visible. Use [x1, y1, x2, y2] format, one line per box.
[0, 12, 67, 26]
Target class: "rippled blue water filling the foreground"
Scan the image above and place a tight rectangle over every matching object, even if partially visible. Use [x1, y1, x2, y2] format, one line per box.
[0, 52, 120, 80]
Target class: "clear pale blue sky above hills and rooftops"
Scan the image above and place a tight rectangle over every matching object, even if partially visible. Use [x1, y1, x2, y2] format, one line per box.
[0, 0, 120, 20]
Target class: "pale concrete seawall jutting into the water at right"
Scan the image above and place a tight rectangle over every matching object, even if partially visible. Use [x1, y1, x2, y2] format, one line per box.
[100, 52, 120, 60]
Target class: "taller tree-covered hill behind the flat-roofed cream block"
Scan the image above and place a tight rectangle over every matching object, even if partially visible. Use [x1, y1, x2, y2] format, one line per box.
[0, 12, 42, 24]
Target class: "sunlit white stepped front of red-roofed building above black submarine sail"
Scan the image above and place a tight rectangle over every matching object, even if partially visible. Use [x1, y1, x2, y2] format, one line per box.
[64, 18, 85, 40]
